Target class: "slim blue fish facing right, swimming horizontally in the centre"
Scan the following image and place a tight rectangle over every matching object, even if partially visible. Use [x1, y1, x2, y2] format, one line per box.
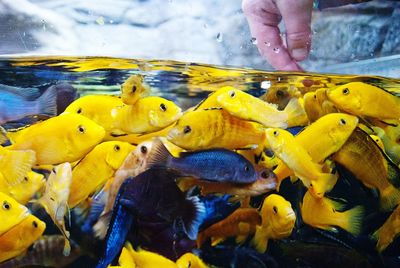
[147, 139, 258, 183]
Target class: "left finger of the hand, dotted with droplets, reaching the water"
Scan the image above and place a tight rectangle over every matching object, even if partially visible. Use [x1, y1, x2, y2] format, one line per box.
[242, 0, 302, 71]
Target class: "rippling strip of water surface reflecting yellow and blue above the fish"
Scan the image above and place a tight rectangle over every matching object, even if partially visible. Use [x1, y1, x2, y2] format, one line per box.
[0, 57, 400, 267]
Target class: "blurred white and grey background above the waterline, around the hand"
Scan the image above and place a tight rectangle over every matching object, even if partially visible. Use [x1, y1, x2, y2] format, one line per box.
[0, 0, 400, 78]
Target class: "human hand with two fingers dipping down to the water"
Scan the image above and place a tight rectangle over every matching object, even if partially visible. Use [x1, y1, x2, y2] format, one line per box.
[242, 0, 313, 71]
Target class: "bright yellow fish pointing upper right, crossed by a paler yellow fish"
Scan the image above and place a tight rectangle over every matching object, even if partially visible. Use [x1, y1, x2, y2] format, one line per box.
[274, 113, 358, 188]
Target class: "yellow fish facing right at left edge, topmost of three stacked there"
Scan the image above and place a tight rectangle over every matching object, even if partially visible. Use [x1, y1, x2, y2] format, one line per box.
[0, 171, 45, 205]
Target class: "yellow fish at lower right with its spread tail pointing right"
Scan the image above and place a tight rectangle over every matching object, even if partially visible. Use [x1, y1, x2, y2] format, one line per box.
[301, 192, 364, 235]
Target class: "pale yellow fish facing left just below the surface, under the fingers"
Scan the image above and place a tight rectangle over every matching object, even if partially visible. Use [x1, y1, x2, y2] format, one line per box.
[216, 88, 307, 128]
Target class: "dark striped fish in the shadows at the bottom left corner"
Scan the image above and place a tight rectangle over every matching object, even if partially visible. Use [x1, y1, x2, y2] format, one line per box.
[0, 235, 81, 268]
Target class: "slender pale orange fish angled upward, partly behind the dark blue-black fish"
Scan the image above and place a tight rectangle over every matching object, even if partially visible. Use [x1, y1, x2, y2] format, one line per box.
[93, 141, 153, 238]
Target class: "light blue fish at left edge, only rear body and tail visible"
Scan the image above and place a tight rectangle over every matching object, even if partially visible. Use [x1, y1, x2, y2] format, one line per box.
[0, 85, 57, 125]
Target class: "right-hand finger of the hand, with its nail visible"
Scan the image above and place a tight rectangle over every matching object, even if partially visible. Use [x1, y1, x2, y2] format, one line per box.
[276, 0, 313, 61]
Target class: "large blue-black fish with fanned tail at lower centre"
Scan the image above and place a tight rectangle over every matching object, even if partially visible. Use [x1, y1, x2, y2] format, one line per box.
[97, 168, 205, 268]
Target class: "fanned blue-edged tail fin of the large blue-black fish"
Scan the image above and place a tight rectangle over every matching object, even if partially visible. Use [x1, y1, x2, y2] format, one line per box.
[183, 196, 206, 240]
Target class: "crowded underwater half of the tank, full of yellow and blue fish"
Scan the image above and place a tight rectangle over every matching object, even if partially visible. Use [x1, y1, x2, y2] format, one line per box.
[0, 57, 400, 268]
